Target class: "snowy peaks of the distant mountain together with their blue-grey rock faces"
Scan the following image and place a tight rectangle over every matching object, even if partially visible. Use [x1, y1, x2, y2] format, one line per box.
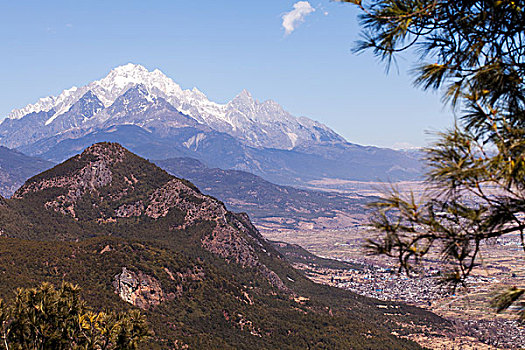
[5, 63, 344, 149]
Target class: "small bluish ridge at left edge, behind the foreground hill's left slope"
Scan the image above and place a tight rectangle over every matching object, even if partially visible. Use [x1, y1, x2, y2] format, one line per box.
[0, 146, 53, 197]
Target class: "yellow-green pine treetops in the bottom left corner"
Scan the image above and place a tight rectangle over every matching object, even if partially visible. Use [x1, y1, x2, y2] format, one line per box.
[0, 283, 149, 350]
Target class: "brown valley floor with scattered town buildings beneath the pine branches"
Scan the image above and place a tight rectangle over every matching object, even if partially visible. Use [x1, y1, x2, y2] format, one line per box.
[262, 226, 525, 349]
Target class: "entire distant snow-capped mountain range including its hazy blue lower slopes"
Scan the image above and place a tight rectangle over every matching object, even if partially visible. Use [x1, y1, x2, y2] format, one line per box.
[0, 64, 421, 186]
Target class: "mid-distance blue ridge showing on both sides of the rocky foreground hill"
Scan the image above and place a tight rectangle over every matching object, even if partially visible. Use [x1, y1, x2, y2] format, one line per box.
[0, 147, 368, 230]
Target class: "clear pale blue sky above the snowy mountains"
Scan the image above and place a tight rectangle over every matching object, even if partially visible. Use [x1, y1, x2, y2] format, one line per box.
[0, 0, 452, 147]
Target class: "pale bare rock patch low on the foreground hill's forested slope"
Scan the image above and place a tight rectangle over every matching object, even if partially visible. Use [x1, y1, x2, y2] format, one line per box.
[113, 267, 169, 310]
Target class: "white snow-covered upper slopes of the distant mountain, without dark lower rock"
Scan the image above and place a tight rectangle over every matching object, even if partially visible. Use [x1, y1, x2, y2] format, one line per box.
[5, 63, 344, 149]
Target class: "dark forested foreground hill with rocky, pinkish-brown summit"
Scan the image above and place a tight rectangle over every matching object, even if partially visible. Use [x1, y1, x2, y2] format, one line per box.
[0, 144, 448, 349]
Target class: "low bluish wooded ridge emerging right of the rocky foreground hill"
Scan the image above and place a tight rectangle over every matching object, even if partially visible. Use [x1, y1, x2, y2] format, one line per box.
[155, 158, 373, 228]
